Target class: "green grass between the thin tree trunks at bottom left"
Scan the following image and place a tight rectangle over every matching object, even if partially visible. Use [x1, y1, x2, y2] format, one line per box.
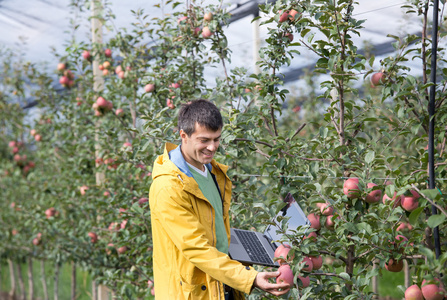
[0, 261, 92, 300]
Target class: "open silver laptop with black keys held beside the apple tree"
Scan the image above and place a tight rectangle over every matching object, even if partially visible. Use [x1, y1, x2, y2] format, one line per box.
[228, 193, 310, 267]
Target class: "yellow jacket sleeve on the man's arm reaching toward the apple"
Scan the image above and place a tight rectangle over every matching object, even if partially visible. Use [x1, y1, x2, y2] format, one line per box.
[151, 181, 258, 294]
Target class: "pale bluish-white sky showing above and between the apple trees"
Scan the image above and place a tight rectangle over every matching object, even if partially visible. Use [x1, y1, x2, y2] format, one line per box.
[0, 0, 440, 86]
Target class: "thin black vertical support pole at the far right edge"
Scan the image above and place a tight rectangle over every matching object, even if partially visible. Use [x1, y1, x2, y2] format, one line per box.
[428, 0, 441, 258]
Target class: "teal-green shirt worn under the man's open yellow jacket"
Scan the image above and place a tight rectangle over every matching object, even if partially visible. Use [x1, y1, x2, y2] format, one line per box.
[188, 165, 228, 254]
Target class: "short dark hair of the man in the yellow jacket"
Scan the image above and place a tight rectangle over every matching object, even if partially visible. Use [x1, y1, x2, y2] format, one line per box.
[178, 99, 223, 136]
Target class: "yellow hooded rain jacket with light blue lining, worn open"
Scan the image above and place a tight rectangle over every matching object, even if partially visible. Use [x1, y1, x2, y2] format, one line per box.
[149, 143, 258, 300]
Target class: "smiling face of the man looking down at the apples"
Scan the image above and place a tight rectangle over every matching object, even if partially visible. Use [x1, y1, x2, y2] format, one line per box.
[180, 123, 222, 170]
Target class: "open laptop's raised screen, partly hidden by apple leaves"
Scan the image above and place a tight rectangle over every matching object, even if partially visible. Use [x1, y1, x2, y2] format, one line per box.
[264, 194, 310, 241]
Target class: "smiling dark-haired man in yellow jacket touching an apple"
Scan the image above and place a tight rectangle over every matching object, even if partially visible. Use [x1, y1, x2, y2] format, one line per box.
[149, 99, 290, 300]
